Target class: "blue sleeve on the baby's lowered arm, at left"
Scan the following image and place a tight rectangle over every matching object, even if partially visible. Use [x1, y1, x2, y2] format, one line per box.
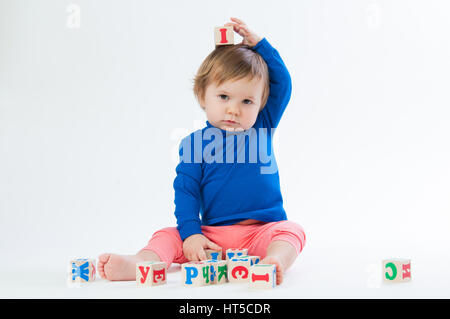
[173, 135, 202, 240]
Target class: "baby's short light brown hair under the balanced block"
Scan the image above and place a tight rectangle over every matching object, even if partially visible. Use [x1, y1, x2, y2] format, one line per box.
[194, 44, 270, 110]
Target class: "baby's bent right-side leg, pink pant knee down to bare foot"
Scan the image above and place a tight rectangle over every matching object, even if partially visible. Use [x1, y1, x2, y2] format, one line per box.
[249, 221, 305, 285]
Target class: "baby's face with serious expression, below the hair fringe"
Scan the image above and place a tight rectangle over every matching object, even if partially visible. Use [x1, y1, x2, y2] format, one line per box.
[200, 77, 264, 132]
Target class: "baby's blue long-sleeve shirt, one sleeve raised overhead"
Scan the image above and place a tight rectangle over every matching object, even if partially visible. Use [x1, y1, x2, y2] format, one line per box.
[173, 38, 292, 240]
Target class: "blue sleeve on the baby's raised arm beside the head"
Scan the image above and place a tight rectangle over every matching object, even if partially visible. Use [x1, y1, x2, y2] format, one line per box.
[252, 38, 292, 128]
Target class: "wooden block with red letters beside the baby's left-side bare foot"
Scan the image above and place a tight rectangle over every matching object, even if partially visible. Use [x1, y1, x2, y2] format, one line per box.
[136, 261, 167, 287]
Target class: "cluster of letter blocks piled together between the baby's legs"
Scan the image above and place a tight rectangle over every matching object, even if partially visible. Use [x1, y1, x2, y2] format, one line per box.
[181, 248, 276, 288]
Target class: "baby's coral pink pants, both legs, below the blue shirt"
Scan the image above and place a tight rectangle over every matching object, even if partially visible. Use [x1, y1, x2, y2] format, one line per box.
[143, 220, 306, 267]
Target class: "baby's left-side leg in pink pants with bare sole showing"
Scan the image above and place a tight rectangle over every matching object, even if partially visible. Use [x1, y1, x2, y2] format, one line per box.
[97, 227, 185, 281]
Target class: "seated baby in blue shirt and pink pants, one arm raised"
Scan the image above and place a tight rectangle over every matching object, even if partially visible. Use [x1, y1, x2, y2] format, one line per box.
[98, 18, 306, 284]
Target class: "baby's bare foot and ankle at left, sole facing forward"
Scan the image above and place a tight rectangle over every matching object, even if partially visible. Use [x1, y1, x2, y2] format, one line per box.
[97, 251, 160, 281]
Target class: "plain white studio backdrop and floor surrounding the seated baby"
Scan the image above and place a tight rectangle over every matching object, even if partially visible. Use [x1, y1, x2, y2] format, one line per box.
[0, 0, 450, 298]
